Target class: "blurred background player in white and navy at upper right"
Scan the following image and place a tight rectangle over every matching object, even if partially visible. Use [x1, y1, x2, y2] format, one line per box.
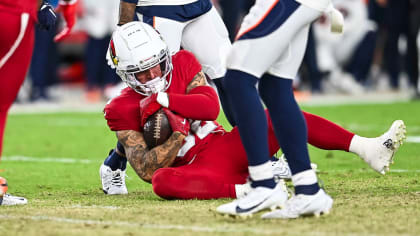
[313, 0, 377, 94]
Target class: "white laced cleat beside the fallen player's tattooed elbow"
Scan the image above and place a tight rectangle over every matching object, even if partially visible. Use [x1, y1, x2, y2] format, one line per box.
[99, 164, 128, 195]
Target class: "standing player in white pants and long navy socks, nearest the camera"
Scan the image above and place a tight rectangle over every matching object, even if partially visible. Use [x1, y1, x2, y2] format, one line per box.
[217, 0, 343, 218]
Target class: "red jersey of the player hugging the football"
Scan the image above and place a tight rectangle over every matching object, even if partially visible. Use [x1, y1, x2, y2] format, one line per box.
[104, 50, 224, 166]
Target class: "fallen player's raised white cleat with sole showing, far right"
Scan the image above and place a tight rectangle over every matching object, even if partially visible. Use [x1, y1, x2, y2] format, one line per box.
[359, 120, 406, 175]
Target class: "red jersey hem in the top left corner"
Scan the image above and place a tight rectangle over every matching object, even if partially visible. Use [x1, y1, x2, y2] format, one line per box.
[0, 0, 38, 21]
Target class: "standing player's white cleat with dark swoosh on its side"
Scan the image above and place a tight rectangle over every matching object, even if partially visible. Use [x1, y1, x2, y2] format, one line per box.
[216, 180, 288, 217]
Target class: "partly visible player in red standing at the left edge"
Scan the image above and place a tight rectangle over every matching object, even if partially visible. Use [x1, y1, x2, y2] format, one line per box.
[0, 0, 77, 205]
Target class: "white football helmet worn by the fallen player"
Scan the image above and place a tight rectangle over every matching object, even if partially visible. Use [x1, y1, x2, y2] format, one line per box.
[107, 21, 172, 96]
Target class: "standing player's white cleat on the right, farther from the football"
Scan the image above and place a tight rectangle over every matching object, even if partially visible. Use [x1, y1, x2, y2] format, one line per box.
[261, 189, 333, 219]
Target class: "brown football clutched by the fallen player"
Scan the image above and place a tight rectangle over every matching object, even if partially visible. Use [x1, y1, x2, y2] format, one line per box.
[143, 109, 172, 149]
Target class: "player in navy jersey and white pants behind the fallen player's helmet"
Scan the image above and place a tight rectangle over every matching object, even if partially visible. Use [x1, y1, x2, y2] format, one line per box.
[108, 0, 235, 126]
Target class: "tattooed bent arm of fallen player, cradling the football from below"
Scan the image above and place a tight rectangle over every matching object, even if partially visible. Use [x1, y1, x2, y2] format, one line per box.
[117, 130, 185, 183]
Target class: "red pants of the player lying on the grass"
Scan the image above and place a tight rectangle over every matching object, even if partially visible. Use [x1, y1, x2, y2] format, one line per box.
[152, 112, 354, 199]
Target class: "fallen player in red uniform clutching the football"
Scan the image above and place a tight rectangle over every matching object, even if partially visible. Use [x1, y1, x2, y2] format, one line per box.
[100, 22, 404, 199]
